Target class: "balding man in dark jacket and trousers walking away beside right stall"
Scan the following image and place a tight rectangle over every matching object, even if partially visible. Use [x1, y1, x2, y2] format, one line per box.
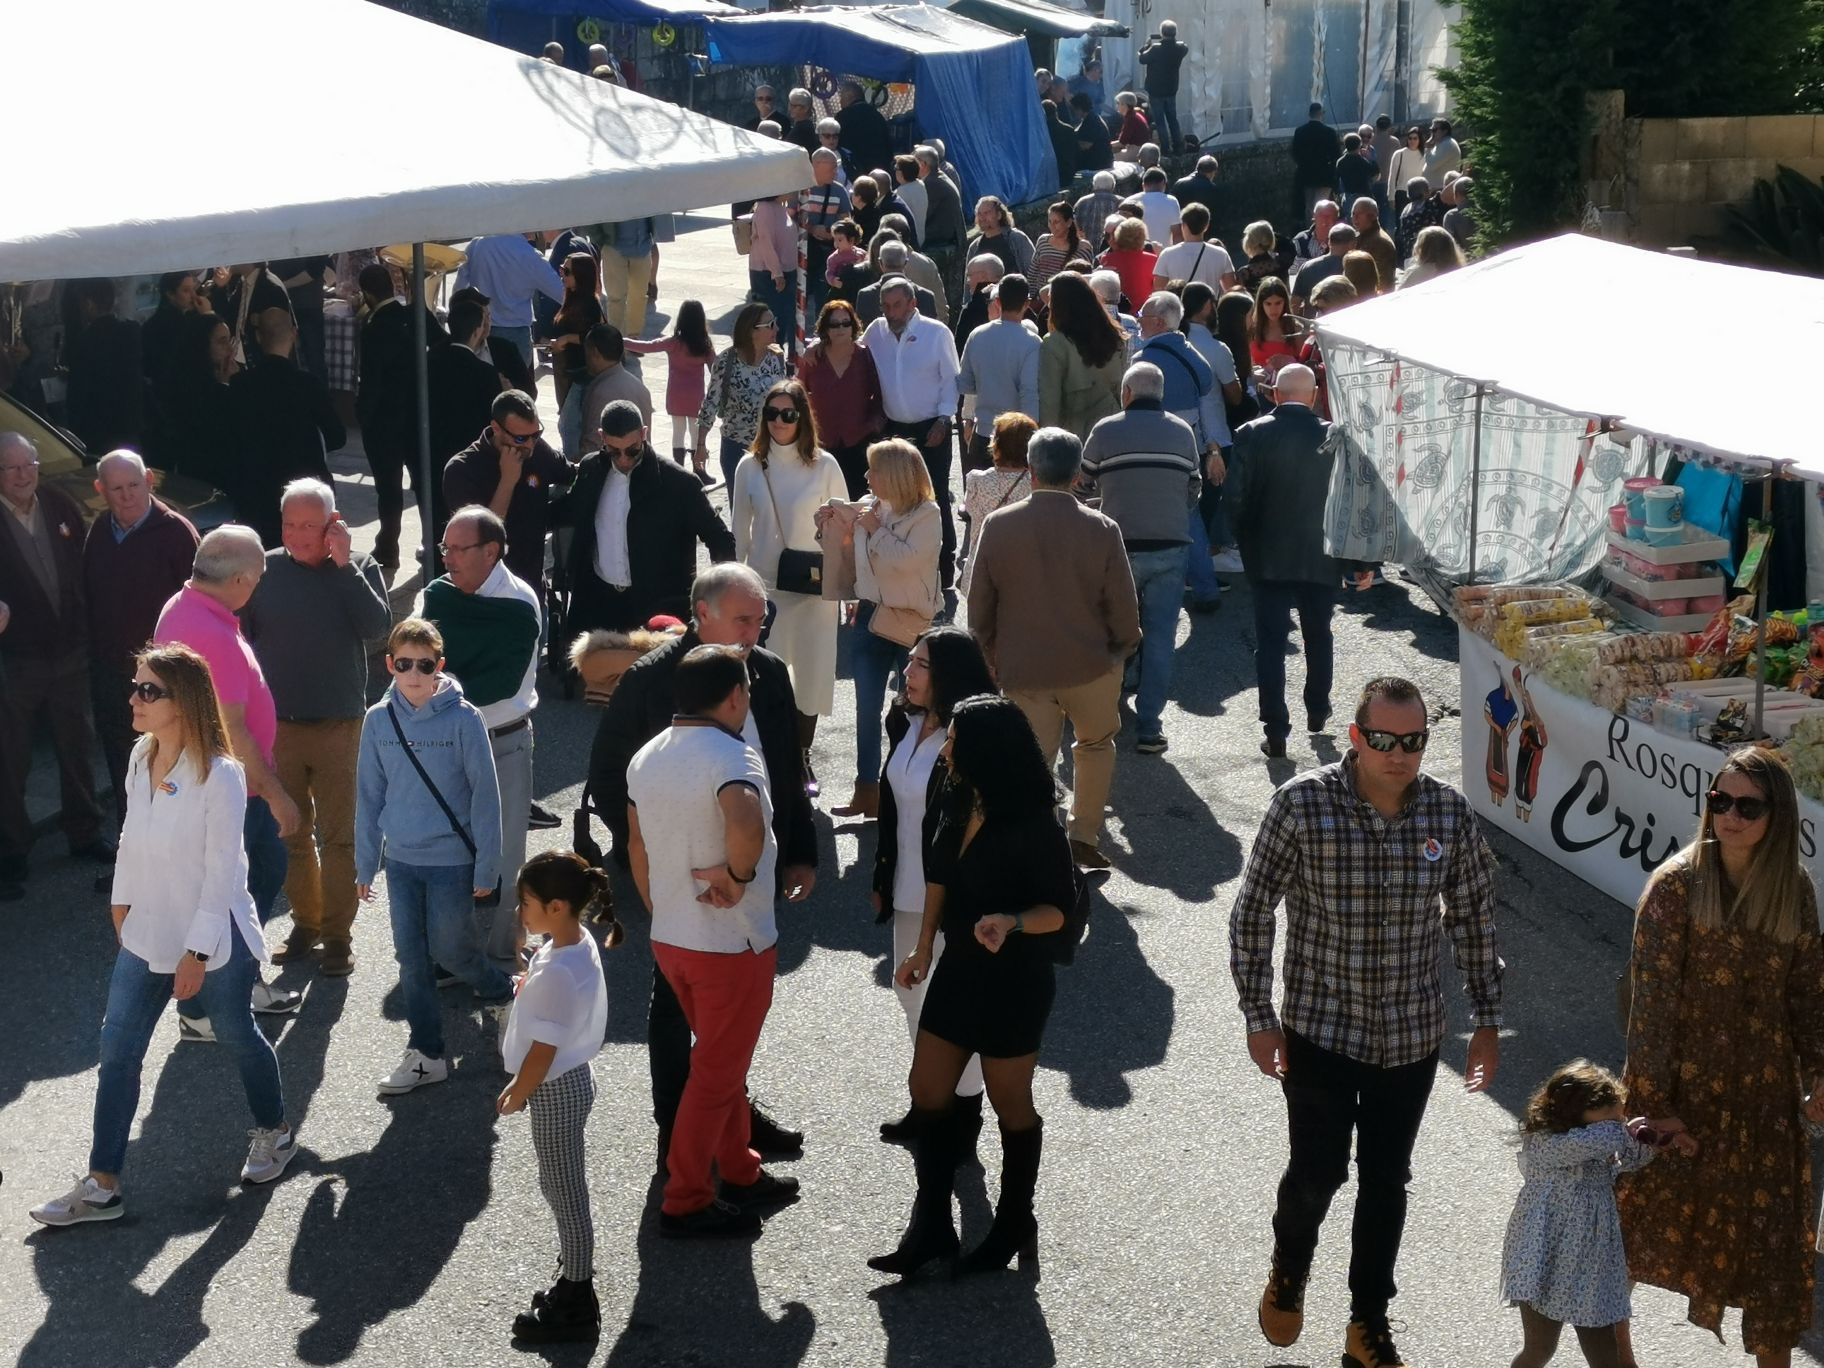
[1222, 363, 1363, 759]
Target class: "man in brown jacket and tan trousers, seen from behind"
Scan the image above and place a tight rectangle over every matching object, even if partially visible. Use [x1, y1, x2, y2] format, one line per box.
[969, 427, 1140, 868]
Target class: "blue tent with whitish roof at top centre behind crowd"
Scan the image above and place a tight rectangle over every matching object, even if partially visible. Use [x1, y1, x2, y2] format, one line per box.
[704, 5, 1058, 210]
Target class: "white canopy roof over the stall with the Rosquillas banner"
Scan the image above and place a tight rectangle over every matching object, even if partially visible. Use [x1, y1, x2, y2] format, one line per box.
[1319, 233, 1824, 480]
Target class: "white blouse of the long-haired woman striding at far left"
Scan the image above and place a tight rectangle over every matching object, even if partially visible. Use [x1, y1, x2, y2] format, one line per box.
[111, 751, 266, 974]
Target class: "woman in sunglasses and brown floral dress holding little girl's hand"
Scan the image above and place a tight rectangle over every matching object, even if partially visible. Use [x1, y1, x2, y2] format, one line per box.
[1616, 746, 1824, 1368]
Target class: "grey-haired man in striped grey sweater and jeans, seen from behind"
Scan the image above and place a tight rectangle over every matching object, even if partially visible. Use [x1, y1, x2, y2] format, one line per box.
[1082, 359, 1209, 755]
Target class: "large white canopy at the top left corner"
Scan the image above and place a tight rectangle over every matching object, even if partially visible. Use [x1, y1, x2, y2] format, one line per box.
[0, 0, 810, 281]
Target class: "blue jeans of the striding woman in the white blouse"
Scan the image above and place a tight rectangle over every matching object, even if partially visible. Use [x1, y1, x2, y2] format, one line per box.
[89, 933, 285, 1175]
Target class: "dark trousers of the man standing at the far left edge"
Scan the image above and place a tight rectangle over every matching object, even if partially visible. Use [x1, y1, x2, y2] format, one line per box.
[0, 649, 102, 863]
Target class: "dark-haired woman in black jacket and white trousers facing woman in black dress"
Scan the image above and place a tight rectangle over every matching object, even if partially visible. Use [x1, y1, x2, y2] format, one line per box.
[870, 627, 998, 1147]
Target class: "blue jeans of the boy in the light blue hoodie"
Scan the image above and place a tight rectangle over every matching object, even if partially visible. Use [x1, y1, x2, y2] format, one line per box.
[387, 859, 518, 1060]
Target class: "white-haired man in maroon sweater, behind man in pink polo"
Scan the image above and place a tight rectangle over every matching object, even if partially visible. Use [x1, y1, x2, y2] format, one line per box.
[82, 451, 197, 846]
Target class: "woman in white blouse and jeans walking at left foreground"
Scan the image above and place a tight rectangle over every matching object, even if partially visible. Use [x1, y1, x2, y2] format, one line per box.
[31, 646, 295, 1226]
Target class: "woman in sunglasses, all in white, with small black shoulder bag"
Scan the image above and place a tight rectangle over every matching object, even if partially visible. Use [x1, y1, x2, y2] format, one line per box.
[730, 379, 848, 797]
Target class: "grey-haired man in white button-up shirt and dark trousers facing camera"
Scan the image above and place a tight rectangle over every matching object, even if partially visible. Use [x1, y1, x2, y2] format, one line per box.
[861, 275, 961, 593]
